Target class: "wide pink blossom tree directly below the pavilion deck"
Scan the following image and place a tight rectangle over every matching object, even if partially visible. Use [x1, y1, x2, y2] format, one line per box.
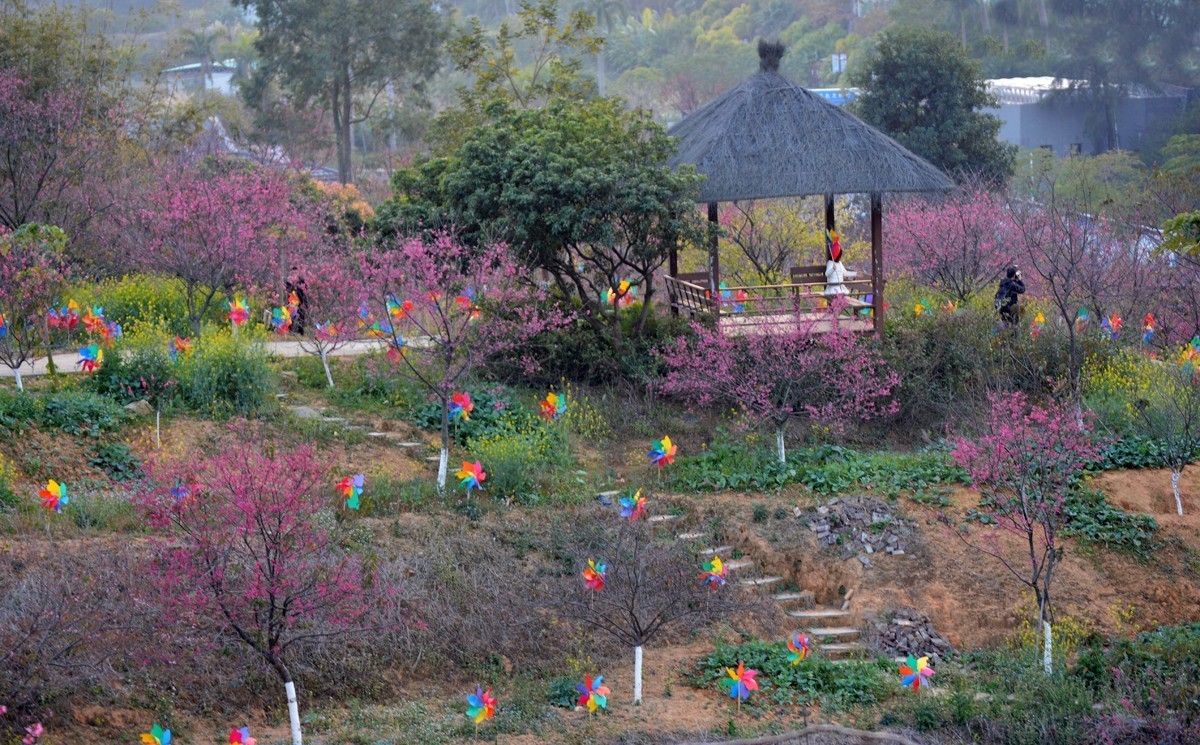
[660, 317, 900, 463]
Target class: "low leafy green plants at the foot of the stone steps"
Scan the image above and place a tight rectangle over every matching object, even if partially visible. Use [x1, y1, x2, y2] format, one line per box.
[688, 639, 895, 709]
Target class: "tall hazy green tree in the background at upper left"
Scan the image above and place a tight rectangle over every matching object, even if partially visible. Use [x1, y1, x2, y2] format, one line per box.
[236, 0, 445, 182]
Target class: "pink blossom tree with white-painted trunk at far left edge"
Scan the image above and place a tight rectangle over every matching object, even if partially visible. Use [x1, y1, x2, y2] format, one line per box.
[0, 223, 68, 390]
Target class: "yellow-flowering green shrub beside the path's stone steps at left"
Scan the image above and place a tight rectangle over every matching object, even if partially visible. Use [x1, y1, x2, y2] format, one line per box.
[176, 326, 274, 417]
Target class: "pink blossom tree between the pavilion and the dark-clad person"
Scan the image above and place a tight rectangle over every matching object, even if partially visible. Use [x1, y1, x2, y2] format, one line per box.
[888, 186, 1014, 301]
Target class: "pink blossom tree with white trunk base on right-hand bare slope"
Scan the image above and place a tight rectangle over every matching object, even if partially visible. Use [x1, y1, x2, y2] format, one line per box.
[953, 393, 1098, 674]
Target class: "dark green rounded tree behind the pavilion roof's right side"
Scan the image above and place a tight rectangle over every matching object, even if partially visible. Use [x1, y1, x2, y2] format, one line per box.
[850, 28, 1016, 184]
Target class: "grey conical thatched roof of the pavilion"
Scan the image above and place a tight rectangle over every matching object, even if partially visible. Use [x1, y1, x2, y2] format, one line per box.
[671, 43, 953, 203]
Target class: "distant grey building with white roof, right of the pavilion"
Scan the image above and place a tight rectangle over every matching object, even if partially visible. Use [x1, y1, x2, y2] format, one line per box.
[988, 77, 1187, 156]
